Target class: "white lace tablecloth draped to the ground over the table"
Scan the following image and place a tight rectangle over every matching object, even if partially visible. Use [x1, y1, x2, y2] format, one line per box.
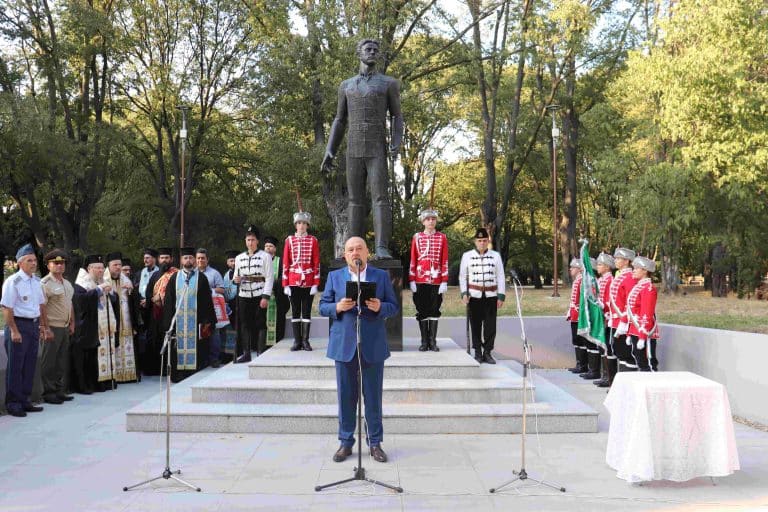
[605, 372, 739, 482]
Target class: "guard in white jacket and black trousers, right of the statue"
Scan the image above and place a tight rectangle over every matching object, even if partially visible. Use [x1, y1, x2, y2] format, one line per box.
[459, 228, 506, 364]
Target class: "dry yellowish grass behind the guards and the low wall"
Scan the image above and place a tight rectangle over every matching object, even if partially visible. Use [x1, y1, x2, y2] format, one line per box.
[403, 286, 768, 334]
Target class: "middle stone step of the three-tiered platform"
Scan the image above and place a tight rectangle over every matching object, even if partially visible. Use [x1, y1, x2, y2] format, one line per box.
[192, 375, 536, 404]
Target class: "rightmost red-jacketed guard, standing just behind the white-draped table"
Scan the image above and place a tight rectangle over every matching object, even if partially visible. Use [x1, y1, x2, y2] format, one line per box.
[627, 256, 659, 372]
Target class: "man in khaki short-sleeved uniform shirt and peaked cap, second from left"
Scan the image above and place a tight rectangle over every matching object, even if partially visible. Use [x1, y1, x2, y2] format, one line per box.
[40, 249, 75, 404]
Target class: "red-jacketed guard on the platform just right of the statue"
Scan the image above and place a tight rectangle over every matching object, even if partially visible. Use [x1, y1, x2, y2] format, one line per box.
[408, 208, 448, 352]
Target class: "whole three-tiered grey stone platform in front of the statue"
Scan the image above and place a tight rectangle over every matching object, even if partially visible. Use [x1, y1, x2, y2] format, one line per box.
[126, 338, 597, 434]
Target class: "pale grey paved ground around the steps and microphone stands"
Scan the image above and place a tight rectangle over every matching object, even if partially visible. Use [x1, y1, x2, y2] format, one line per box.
[0, 362, 768, 512]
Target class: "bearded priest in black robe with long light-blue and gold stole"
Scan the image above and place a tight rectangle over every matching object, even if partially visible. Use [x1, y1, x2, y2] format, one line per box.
[163, 247, 216, 382]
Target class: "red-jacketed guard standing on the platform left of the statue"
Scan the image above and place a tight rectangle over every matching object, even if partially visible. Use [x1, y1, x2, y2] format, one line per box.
[283, 204, 320, 351]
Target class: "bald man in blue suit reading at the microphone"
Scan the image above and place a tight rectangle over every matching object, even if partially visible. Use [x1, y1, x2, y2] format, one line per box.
[320, 237, 398, 462]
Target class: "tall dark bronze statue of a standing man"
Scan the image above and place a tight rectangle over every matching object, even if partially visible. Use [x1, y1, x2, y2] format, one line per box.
[322, 39, 403, 258]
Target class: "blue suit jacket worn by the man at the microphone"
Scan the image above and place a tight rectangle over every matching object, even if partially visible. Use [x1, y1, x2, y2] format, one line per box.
[320, 265, 399, 363]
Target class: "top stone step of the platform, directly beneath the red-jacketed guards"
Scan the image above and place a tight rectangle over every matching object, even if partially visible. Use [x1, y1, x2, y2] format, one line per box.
[248, 338, 485, 380]
